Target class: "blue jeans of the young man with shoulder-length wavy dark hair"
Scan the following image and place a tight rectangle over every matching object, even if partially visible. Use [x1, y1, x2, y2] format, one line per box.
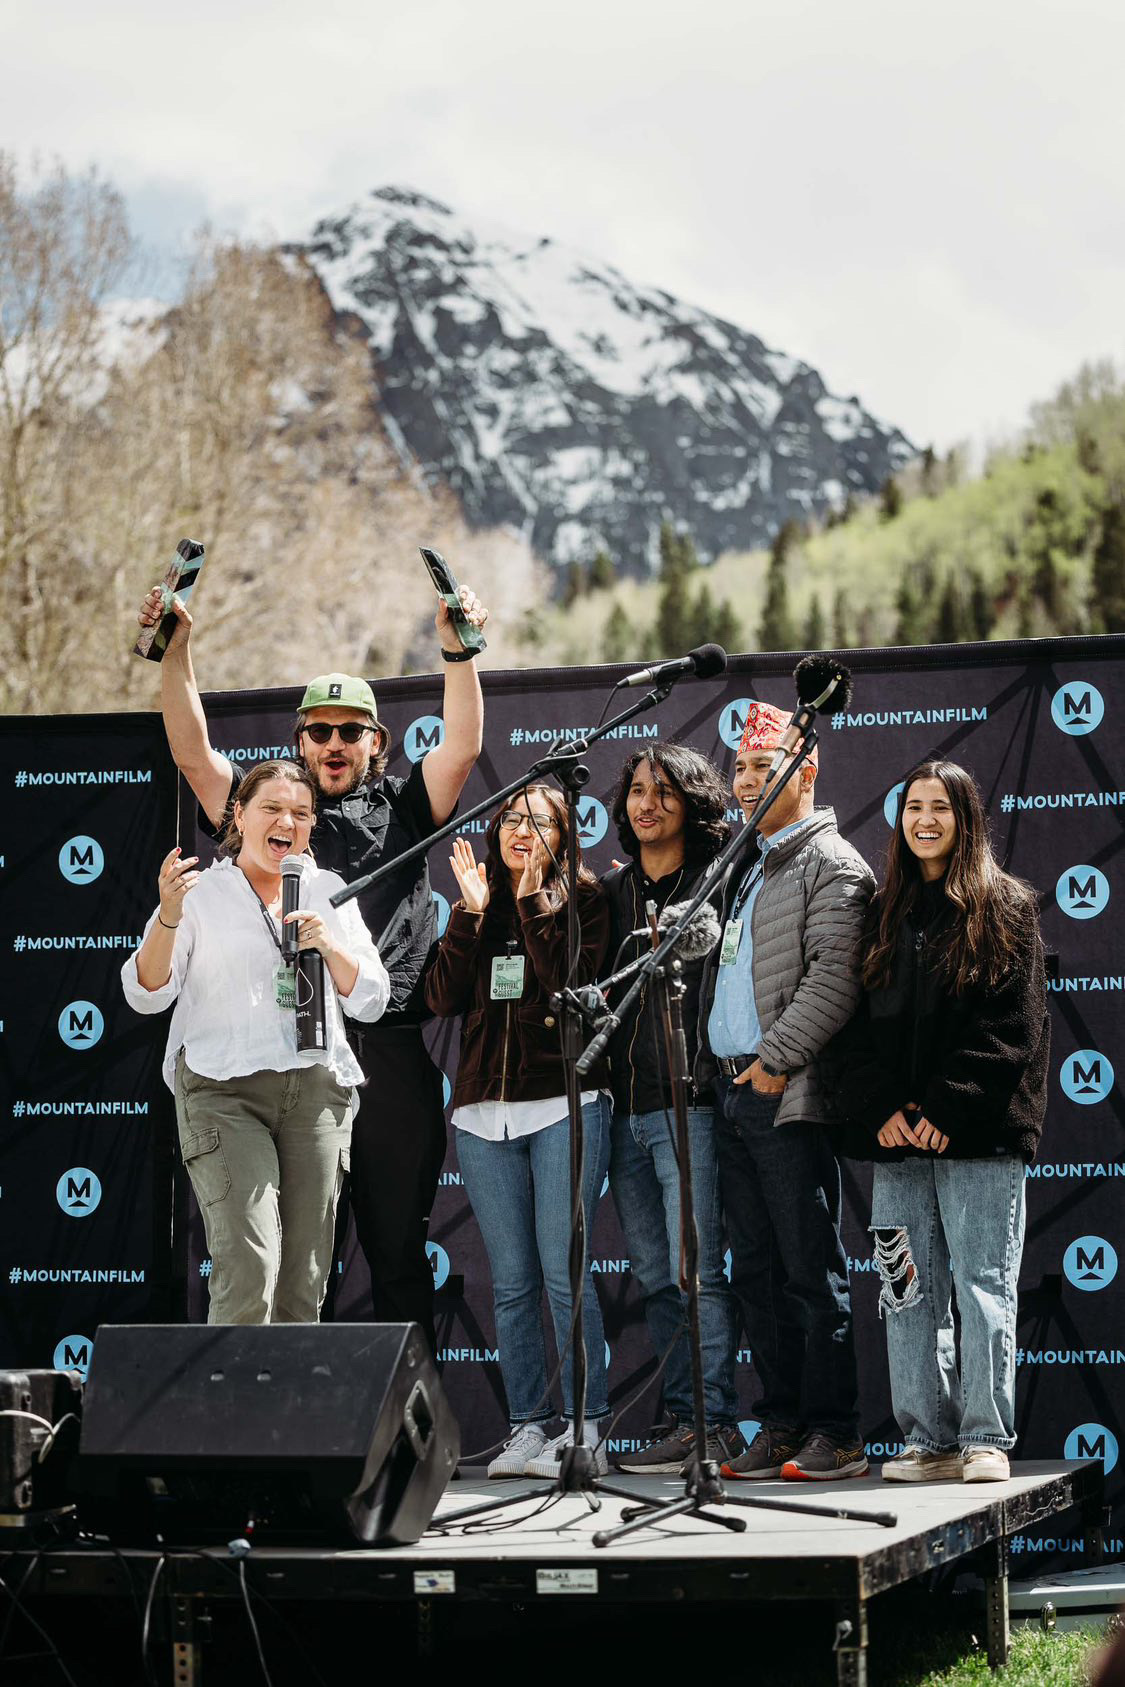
[609, 1107, 739, 1427]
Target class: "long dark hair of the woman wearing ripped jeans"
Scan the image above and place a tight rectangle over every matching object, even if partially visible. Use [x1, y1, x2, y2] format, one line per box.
[864, 756, 1037, 995]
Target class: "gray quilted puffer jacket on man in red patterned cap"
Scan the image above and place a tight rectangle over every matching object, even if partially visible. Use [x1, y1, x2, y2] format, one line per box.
[693, 808, 875, 1124]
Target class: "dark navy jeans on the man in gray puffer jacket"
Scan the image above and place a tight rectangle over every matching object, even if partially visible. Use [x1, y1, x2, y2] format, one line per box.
[715, 1078, 857, 1441]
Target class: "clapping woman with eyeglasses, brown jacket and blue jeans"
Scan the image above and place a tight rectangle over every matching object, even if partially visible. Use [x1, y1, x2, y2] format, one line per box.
[425, 784, 611, 1478]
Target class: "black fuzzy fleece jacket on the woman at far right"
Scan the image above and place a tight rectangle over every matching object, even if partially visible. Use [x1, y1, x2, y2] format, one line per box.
[832, 881, 1051, 1162]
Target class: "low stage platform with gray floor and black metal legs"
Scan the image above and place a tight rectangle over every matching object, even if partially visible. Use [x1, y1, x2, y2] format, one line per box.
[8, 1461, 1103, 1687]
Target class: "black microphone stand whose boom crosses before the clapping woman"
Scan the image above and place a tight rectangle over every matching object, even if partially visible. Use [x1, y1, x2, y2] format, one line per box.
[340, 675, 694, 1528]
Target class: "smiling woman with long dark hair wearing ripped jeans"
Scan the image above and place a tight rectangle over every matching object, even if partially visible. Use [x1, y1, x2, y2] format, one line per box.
[840, 757, 1049, 1481]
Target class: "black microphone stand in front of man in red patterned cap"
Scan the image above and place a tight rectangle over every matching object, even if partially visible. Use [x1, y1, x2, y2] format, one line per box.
[577, 717, 897, 1547]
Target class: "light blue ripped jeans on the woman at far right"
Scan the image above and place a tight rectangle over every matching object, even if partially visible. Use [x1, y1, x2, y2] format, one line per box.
[870, 1154, 1025, 1453]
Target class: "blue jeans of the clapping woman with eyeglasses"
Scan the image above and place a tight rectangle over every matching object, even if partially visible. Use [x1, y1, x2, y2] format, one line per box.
[457, 1095, 609, 1426]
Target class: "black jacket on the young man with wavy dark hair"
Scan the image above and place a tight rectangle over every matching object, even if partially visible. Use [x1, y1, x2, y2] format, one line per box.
[602, 860, 719, 1113]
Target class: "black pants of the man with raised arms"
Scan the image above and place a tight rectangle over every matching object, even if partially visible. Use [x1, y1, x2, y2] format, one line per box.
[351, 1024, 445, 1348]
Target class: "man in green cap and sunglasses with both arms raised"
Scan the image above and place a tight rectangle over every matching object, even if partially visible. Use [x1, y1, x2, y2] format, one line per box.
[138, 585, 487, 1346]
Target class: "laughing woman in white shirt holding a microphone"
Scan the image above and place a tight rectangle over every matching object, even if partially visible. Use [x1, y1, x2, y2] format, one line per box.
[121, 761, 390, 1324]
